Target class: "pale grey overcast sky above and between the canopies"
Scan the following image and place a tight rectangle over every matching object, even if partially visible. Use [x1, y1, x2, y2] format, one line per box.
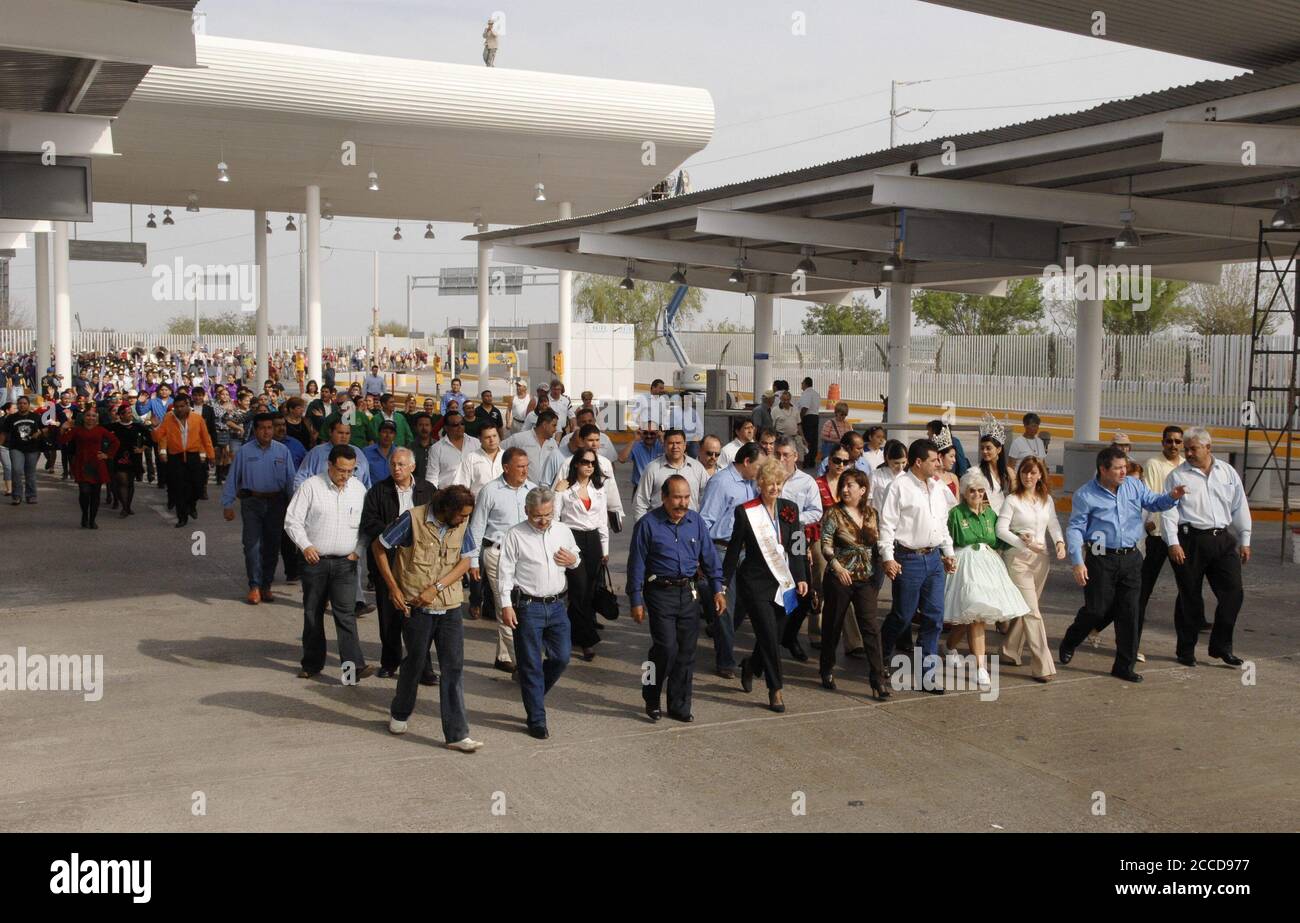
[10, 0, 1240, 335]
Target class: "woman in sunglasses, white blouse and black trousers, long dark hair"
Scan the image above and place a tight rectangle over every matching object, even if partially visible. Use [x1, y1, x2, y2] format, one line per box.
[555, 447, 610, 660]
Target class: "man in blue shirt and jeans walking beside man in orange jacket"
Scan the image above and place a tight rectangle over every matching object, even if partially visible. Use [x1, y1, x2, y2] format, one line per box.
[221, 413, 294, 606]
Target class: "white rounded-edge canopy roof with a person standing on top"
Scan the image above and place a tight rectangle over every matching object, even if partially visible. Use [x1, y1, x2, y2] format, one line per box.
[86, 35, 714, 224]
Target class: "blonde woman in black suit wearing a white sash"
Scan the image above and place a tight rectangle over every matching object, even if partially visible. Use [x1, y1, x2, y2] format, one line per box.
[723, 459, 809, 712]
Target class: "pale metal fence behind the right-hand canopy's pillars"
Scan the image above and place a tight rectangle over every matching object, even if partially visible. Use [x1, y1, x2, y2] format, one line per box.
[650, 333, 1290, 426]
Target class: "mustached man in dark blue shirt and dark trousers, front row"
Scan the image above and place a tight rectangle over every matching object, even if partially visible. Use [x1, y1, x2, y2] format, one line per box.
[628, 475, 727, 722]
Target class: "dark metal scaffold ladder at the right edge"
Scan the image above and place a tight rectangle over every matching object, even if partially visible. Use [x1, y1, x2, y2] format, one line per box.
[1242, 225, 1300, 560]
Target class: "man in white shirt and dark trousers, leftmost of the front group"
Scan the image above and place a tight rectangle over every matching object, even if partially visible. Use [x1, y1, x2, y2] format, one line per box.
[285, 443, 374, 685]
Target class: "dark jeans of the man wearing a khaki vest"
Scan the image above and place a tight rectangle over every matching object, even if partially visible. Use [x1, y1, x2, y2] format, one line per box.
[392, 608, 469, 744]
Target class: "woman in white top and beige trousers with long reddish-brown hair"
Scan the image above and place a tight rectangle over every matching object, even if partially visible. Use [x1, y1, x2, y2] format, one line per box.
[997, 455, 1065, 683]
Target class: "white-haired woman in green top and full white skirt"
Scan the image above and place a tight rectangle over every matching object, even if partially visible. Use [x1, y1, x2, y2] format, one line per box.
[944, 469, 1030, 688]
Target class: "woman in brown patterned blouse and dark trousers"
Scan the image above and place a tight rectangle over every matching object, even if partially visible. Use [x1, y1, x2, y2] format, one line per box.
[820, 473, 889, 698]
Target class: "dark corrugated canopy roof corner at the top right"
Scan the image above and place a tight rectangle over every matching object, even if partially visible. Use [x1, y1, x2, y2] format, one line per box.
[926, 0, 1300, 68]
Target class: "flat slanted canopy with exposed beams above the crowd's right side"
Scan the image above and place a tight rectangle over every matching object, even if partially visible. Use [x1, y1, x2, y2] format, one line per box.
[468, 65, 1300, 300]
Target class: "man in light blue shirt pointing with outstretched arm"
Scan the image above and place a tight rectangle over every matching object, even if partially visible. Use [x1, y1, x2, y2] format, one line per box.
[1060, 446, 1187, 683]
